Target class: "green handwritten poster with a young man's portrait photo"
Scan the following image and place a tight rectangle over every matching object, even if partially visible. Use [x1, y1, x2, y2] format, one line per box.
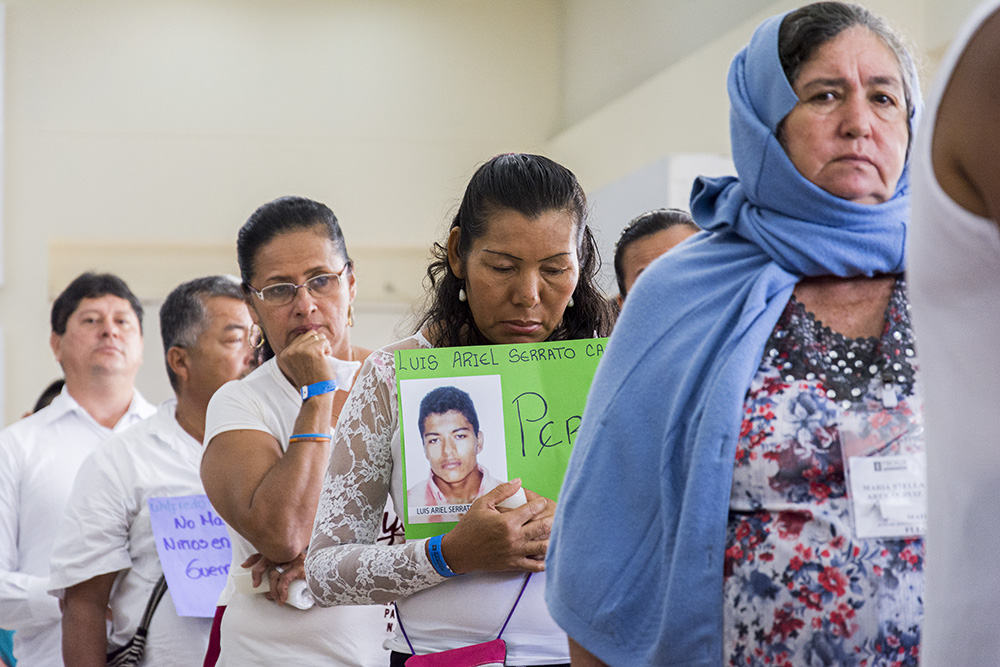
[396, 338, 607, 538]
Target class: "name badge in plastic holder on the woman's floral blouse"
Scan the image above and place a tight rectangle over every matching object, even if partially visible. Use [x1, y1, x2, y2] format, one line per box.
[840, 378, 927, 538]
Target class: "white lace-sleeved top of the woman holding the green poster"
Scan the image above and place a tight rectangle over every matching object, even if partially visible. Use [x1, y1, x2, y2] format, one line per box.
[306, 334, 569, 665]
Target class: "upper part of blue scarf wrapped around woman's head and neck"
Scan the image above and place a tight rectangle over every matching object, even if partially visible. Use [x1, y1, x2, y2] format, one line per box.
[691, 15, 919, 277]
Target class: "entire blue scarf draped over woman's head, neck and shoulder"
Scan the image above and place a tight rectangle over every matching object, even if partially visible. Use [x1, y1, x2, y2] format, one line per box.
[546, 10, 919, 667]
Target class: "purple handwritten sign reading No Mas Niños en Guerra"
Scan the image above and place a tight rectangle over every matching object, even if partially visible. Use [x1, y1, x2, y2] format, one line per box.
[147, 495, 233, 618]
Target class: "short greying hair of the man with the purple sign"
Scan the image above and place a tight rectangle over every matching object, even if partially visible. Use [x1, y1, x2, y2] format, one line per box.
[160, 276, 249, 390]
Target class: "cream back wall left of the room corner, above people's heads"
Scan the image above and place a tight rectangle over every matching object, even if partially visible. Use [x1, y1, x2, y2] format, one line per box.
[0, 0, 560, 422]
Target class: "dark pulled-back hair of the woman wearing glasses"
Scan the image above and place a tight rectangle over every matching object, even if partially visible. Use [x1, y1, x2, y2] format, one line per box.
[236, 197, 352, 361]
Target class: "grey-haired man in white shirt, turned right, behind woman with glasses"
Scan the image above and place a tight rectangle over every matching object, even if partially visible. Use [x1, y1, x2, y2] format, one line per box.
[49, 276, 253, 667]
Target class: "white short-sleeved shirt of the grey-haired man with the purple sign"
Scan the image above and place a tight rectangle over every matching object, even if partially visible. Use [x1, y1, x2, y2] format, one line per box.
[49, 399, 212, 667]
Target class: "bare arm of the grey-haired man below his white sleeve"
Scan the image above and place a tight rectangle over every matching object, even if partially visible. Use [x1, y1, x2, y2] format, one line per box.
[62, 572, 118, 667]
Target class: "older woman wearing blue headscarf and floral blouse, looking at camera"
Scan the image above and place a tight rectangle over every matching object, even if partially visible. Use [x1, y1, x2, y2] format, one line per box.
[546, 2, 923, 667]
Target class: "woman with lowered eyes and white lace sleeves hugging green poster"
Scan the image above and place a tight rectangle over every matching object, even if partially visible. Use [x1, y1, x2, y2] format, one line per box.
[306, 154, 611, 665]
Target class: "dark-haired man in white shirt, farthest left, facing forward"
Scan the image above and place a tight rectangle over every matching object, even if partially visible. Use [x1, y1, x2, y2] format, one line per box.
[0, 273, 154, 667]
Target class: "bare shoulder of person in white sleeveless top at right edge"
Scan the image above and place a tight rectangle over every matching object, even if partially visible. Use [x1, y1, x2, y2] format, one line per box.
[931, 11, 1000, 222]
